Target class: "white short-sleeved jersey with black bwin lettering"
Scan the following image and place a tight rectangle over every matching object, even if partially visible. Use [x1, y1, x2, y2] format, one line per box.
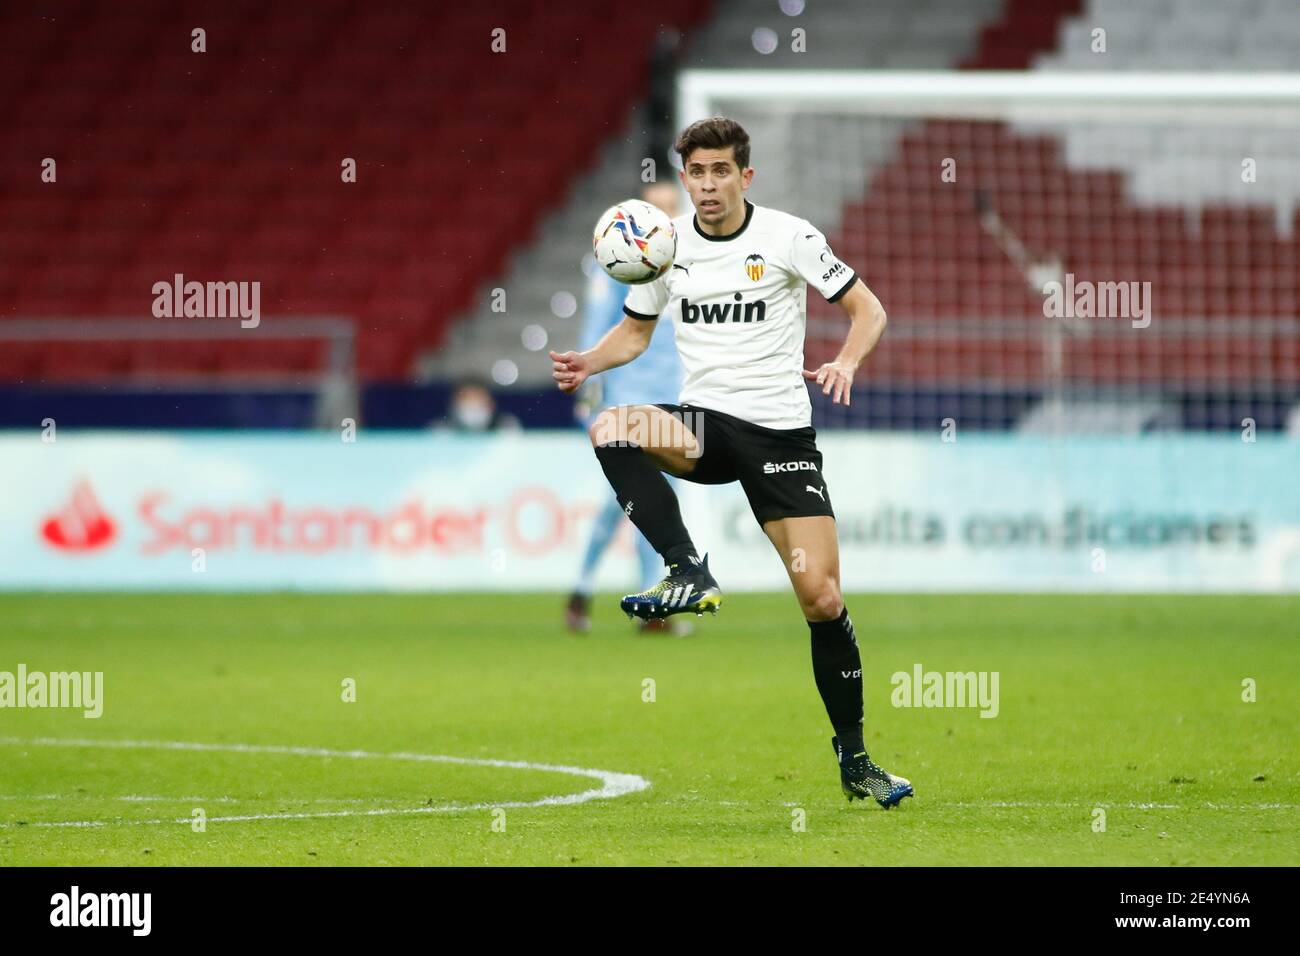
[623, 200, 857, 428]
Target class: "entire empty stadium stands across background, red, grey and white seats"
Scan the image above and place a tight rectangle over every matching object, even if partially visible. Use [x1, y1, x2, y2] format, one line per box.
[0, 0, 1300, 428]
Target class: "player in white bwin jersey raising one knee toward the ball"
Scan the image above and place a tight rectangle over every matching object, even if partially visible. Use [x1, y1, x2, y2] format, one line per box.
[550, 117, 913, 809]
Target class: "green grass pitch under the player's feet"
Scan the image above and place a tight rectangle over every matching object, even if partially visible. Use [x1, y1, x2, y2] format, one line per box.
[0, 592, 1300, 865]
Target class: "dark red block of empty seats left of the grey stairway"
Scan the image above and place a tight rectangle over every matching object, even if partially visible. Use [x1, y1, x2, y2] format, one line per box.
[0, 0, 709, 381]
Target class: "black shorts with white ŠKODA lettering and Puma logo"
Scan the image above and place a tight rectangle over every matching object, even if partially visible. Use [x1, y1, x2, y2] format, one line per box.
[655, 402, 835, 525]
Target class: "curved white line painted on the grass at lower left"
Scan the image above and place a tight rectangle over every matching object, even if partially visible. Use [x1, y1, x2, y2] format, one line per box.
[0, 737, 650, 829]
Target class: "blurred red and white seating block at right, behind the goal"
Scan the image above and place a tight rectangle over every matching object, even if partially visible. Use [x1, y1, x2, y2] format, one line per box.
[790, 0, 1300, 428]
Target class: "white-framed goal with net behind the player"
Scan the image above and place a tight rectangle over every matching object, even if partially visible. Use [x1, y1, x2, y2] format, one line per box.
[679, 70, 1300, 433]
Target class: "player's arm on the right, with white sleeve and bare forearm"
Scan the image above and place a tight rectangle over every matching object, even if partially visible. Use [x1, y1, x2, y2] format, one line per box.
[790, 227, 885, 405]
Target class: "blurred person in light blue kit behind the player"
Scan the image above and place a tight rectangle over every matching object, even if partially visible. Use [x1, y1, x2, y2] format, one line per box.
[564, 182, 692, 635]
